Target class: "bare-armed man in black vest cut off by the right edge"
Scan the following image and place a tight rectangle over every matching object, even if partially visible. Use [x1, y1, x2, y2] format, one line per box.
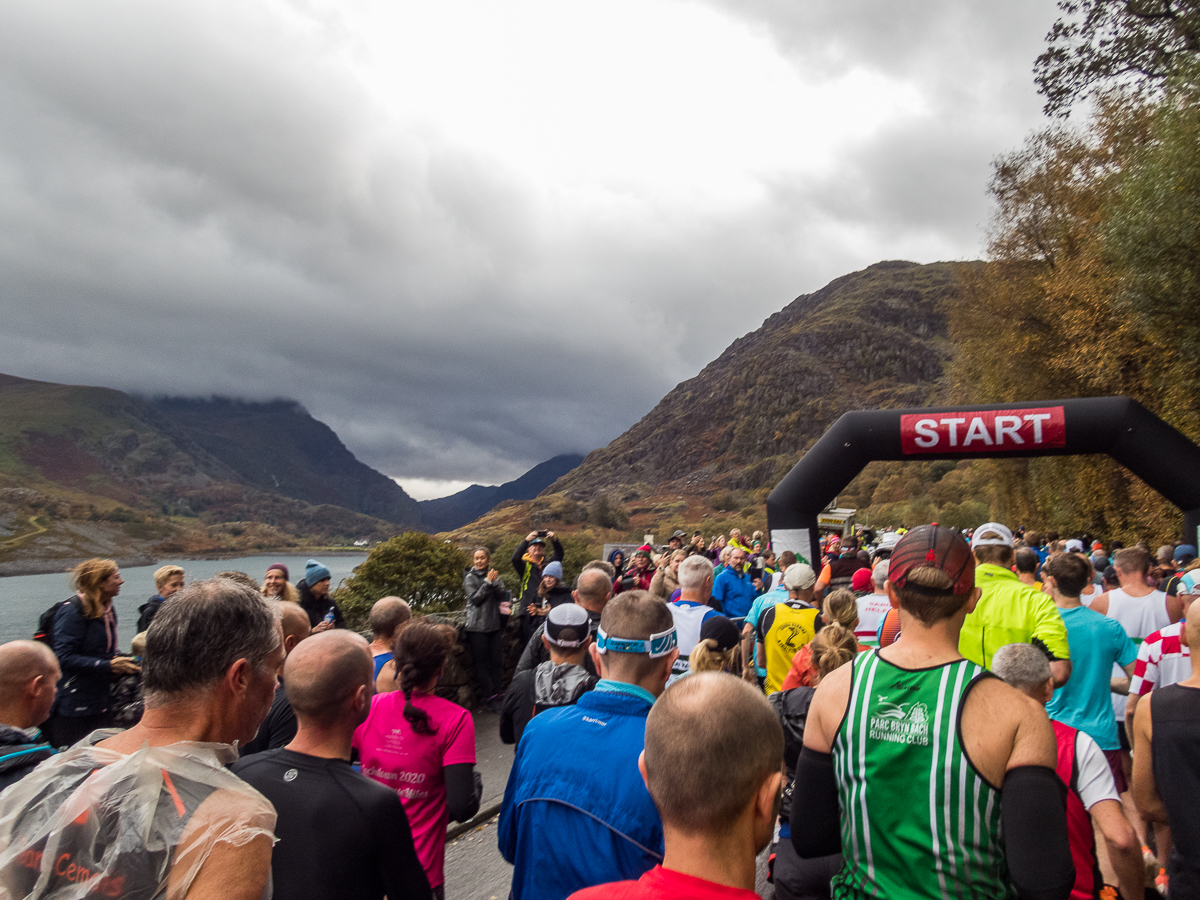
[1133, 601, 1200, 898]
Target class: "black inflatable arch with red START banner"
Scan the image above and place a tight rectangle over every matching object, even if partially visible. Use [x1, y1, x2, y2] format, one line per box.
[767, 397, 1200, 560]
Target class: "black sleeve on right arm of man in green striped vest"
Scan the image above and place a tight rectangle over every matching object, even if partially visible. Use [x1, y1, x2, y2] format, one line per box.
[1000, 766, 1075, 900]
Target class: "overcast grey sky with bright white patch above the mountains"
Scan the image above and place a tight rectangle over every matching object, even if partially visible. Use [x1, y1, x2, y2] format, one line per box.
[0, 0, 1056, 498]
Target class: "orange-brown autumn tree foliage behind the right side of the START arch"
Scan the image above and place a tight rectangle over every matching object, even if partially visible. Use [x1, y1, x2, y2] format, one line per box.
[949, 74, 1200, 539]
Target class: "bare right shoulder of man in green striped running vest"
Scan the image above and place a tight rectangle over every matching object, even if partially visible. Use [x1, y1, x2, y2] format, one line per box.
[961, 677, 1056, 787]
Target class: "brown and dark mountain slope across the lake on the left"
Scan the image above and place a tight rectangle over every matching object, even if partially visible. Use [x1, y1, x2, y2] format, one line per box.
[0, 376, 420, 574]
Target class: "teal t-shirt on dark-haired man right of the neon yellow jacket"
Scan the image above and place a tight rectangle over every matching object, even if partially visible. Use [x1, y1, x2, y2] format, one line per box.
[1046, 606, 1138, 750]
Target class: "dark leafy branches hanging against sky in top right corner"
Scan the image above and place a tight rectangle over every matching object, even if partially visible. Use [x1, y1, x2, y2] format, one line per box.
[1033, 0, 1200, 116]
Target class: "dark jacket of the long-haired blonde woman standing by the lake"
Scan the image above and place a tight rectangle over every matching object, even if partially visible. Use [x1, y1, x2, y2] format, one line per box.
[54, 602, 116, 716]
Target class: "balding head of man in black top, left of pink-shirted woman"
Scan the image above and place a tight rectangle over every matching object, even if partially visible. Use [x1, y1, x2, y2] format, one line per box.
[283, 629, 374, 727]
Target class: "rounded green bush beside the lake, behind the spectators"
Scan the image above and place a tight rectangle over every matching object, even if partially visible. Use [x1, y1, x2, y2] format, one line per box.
[336, 532, 468, 628]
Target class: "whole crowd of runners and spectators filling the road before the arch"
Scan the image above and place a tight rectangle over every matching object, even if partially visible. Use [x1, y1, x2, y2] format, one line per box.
[0, 522, 1200, 900]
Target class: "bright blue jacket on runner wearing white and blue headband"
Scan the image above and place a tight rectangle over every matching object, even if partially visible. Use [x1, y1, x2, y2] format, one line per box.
[498, 691, 662, 900]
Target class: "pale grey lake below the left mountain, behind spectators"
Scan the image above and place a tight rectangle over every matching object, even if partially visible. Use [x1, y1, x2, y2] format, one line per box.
[0, 553, 367, 649]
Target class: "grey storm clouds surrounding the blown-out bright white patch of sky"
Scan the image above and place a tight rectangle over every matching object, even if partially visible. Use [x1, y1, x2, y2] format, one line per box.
[0, 0, 1052, 482]
